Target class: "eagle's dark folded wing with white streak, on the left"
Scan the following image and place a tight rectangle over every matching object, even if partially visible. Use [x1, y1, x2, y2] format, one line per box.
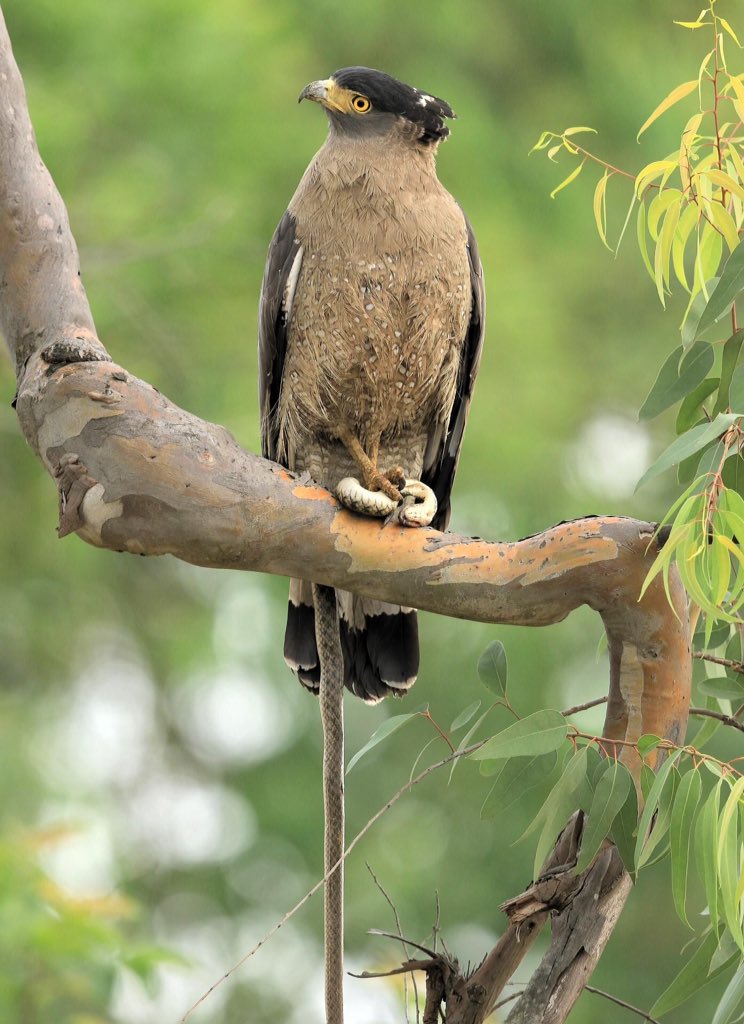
[258, 210, 302, 459]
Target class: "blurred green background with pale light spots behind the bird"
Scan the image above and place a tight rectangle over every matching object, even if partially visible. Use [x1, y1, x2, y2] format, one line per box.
[0, 0, 741, 1024]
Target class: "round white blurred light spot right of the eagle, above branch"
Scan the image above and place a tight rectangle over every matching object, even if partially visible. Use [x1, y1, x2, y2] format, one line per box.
[566, 413, 651, 498]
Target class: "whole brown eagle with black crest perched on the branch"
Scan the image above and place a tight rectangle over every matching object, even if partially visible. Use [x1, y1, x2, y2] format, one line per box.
[259, 68, 483, 700]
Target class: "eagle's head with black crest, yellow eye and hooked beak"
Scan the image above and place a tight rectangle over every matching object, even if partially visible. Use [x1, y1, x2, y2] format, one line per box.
[300, 68, 456, 145]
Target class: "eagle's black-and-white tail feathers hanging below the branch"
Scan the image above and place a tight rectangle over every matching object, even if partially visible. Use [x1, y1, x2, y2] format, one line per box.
[285, 580, 419, 703]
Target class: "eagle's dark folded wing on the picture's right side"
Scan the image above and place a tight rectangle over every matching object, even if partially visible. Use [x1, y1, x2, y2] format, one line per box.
[422, 214, 486, 529]
